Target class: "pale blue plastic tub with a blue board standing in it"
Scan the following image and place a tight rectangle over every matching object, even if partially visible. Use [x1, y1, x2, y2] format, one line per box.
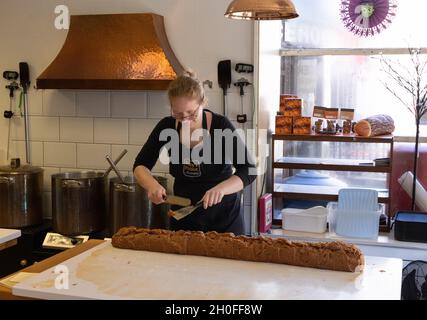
[327, 202, 385, 239]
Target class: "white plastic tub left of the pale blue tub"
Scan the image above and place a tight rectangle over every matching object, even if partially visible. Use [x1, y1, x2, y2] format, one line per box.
[282, 207, 328, 233]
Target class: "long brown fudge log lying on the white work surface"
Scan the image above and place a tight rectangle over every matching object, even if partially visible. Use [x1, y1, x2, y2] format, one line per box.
[112, 227, 364, 272]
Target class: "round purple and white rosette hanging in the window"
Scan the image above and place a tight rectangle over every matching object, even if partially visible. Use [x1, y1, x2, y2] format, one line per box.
[340, 0, 397, 37]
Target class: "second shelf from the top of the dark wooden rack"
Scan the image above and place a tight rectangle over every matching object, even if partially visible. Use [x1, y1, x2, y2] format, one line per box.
[273, 157, 391, 173]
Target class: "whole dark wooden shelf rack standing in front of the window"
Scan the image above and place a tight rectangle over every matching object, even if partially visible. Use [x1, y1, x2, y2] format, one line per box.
[271, 133, 394, 232]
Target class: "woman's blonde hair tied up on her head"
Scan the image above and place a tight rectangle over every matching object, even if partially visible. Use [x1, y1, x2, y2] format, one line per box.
[168, 70, 208, 105]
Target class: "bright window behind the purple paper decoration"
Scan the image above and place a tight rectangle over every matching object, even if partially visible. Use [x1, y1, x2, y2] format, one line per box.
[281, 0, 427, 136]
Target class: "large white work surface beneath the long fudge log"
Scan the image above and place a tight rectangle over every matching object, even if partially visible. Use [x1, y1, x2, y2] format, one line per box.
[13, 242, 402, 300]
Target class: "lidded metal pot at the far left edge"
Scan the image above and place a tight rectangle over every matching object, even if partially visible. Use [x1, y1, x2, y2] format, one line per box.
[0, 159, 43, 228]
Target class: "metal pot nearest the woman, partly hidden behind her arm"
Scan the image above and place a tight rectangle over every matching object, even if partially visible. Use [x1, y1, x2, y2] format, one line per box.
[109, 176, 170, 235]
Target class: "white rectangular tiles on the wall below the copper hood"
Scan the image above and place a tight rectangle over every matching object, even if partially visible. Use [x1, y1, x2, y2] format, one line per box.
[28, 87, 252, 217]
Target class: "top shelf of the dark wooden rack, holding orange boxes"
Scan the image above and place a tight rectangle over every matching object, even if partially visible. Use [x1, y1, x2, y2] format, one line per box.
[272, 134, 393, 143]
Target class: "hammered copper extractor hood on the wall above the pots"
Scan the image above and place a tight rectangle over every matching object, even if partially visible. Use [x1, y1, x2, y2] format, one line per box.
[37, 13, 183, 90]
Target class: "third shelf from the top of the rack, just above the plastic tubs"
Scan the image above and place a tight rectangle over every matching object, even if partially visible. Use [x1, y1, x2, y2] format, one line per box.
[273, 183, 389, 203]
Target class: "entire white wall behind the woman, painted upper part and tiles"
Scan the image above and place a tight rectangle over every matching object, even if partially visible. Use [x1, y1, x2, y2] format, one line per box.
[0, 0, 253, 216]
